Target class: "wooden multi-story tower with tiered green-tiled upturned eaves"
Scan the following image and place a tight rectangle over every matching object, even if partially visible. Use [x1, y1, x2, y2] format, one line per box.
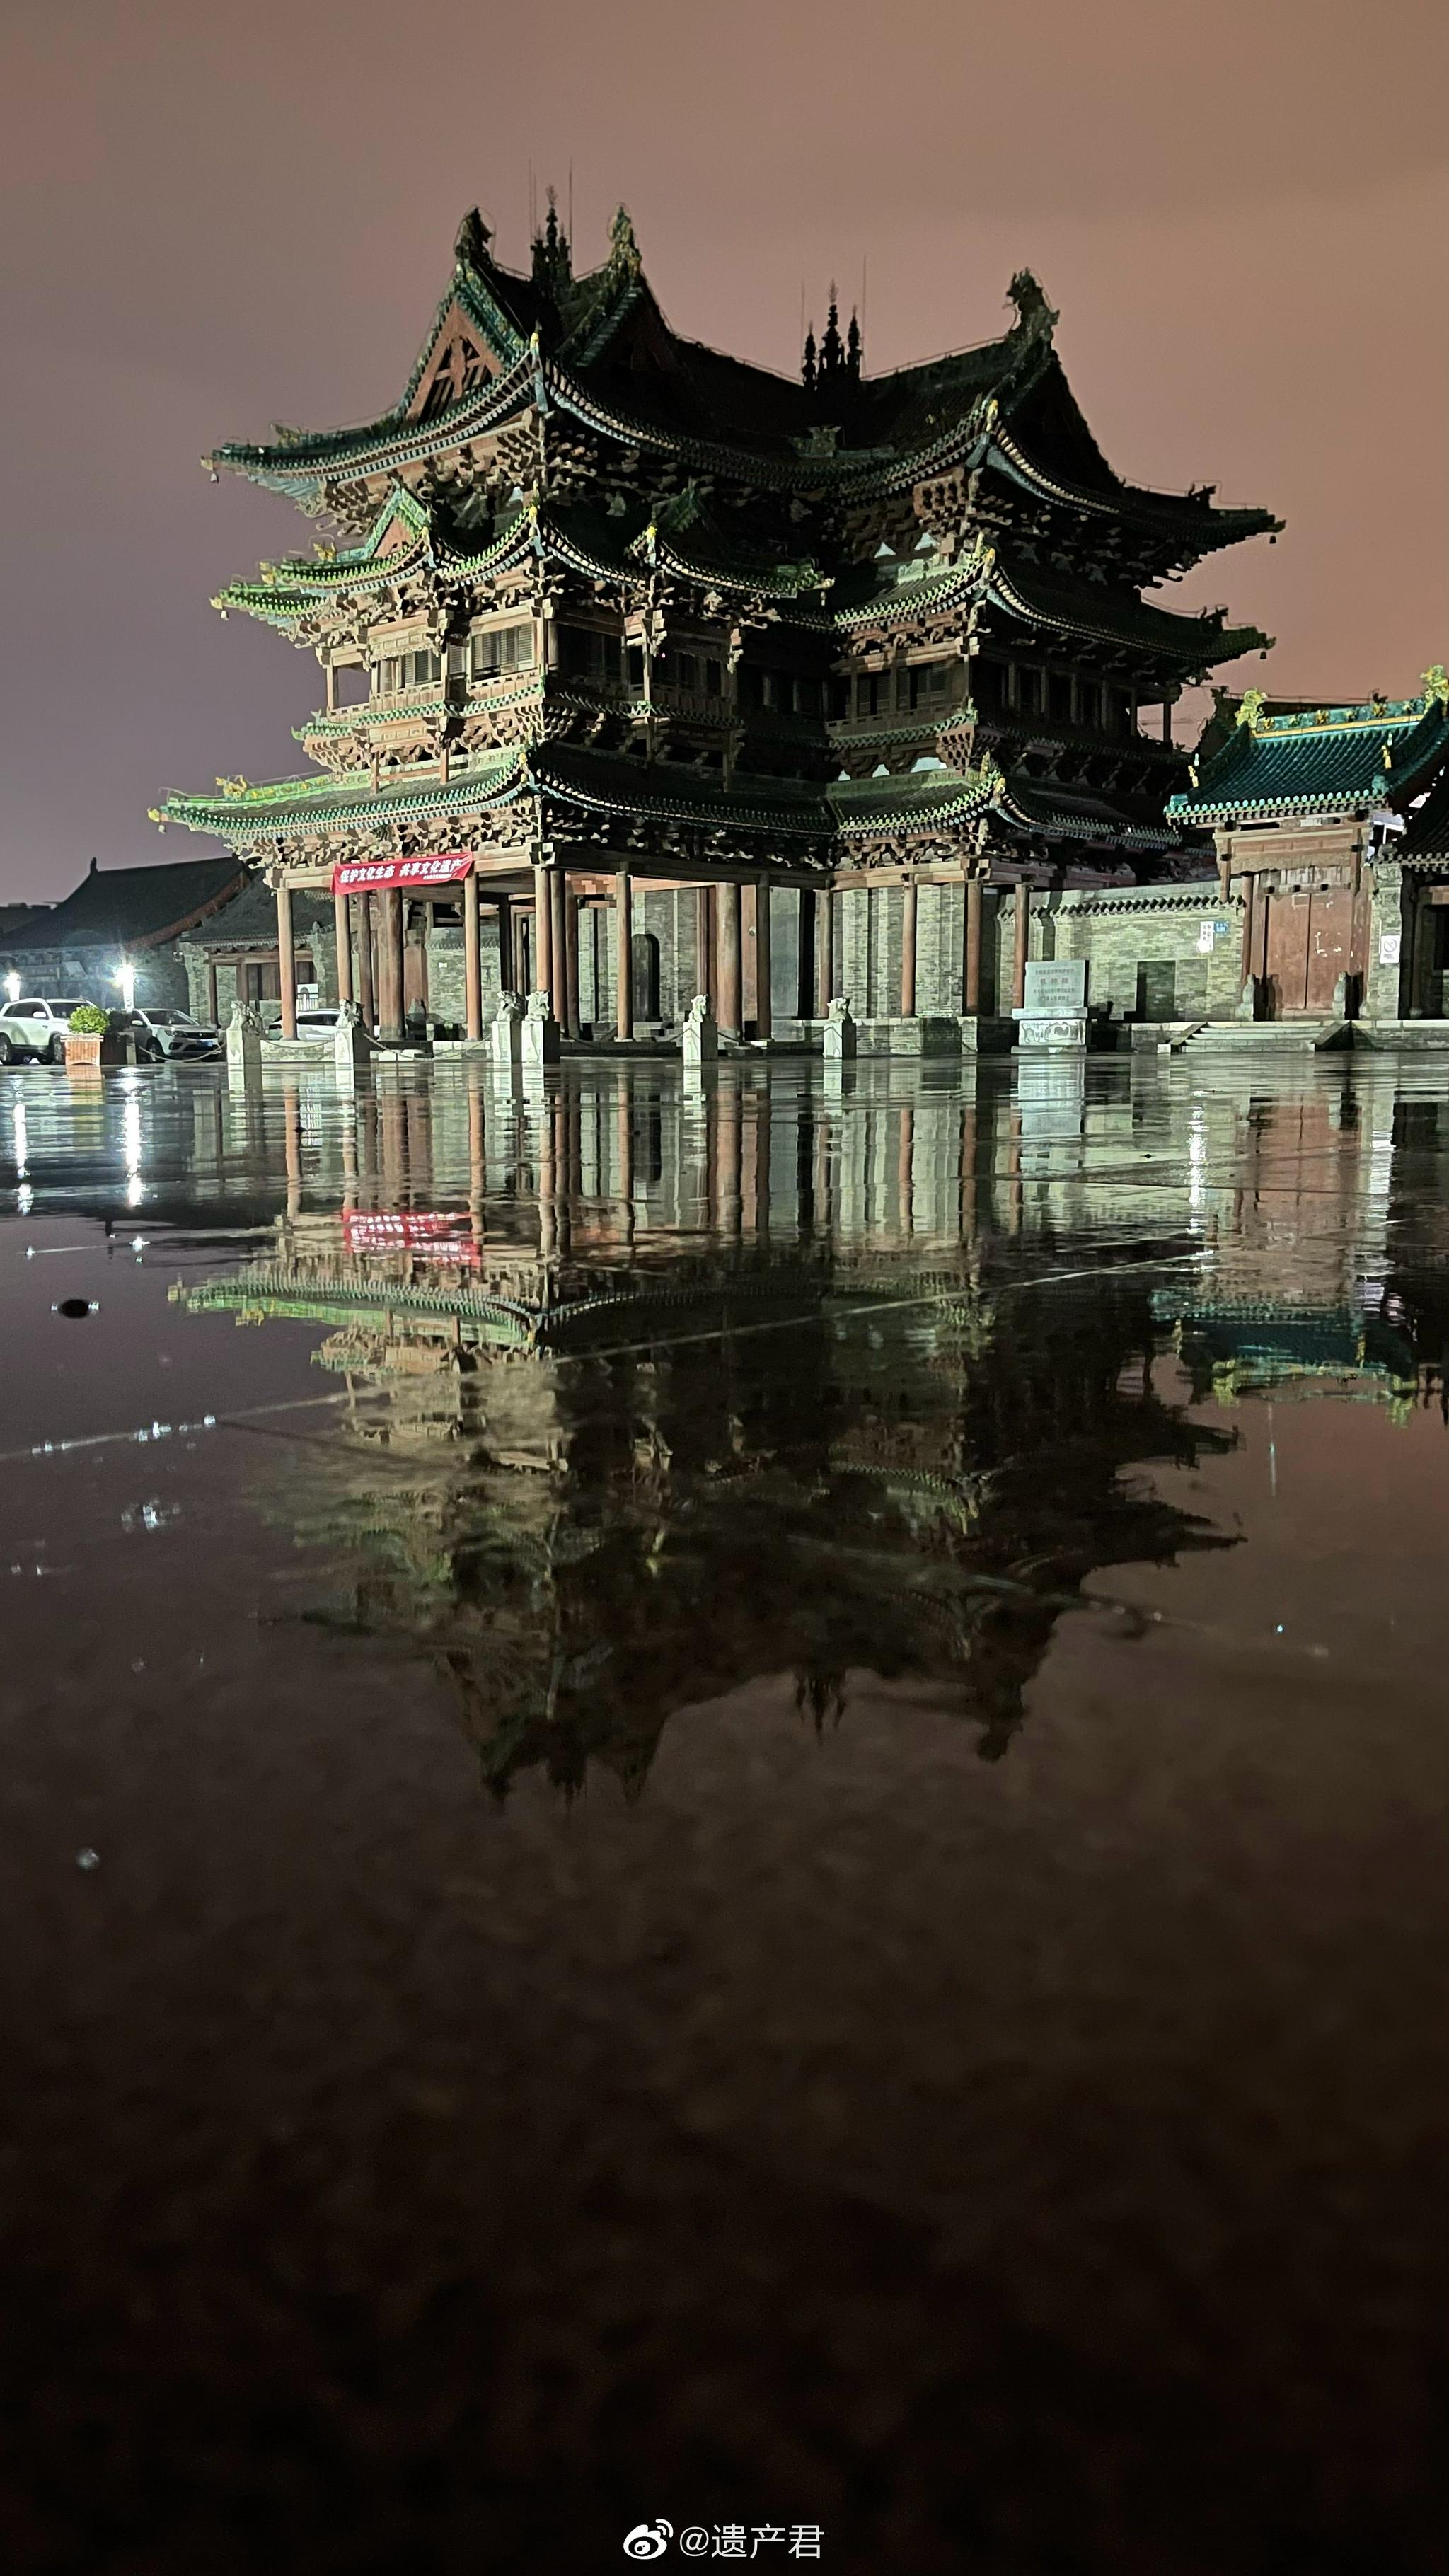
[157, 209, 1276, 1036]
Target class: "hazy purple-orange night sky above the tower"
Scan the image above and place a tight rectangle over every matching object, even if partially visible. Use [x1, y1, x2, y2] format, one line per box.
[0, 0, 1449, 899]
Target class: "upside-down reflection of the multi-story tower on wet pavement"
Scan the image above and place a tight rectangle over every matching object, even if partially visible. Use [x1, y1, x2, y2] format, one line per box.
[178, 1069, 1242, 1788]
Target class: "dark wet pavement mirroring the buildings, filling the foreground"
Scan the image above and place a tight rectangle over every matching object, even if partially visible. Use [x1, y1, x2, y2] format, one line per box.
[0, 1056, 1449, 2576]
